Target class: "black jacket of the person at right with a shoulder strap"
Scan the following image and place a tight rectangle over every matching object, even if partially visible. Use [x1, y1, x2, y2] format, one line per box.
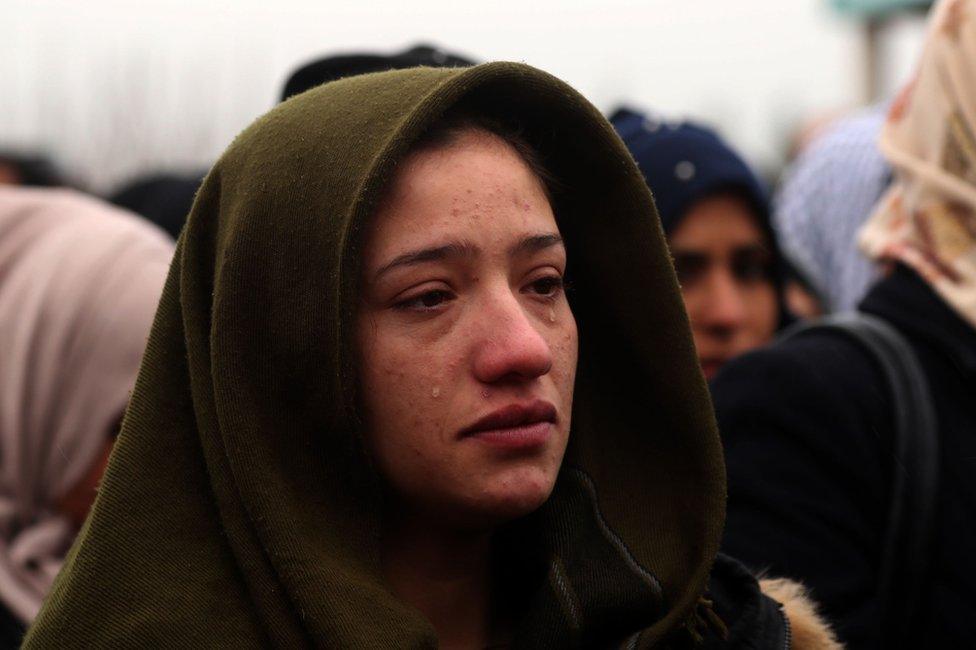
[712, 267, 976, 648]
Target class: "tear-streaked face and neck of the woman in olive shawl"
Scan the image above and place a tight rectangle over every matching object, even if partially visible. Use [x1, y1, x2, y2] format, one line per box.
[357, 130, 577, 648]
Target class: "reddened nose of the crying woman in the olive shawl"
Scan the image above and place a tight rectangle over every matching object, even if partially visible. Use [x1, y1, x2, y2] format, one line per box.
[474, 291, 552, 383]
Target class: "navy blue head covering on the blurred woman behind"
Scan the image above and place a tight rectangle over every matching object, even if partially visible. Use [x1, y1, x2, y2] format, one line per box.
[610, 108, 772, 236]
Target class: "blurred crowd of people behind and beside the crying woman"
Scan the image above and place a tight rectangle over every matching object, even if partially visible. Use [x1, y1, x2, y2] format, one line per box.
[0, 0, 976, 648]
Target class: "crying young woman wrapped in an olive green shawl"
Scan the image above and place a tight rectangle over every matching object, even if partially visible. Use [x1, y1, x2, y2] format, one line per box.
[26, 63, 835, 648]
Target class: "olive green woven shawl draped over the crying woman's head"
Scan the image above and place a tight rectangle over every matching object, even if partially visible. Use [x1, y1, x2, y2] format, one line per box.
[26, 63, 725, 648]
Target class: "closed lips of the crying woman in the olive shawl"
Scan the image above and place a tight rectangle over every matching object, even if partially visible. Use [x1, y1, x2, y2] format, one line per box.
[459, 400, 556, 450]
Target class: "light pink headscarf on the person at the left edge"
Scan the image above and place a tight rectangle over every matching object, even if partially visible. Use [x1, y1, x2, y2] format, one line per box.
[0, 186, 173, 623]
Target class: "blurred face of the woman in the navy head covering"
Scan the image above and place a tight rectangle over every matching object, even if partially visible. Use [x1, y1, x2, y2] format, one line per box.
[669, 194, 777, 379]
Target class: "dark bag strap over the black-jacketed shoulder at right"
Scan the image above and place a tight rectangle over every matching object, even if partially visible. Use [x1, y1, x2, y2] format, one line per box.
[782, 312, 939, 648]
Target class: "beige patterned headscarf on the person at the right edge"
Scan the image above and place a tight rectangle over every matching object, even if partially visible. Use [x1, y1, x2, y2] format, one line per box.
[860, 0, 976, 327]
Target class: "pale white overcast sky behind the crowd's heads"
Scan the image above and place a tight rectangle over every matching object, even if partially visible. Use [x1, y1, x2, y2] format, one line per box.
[0, 0, 922, 191]
